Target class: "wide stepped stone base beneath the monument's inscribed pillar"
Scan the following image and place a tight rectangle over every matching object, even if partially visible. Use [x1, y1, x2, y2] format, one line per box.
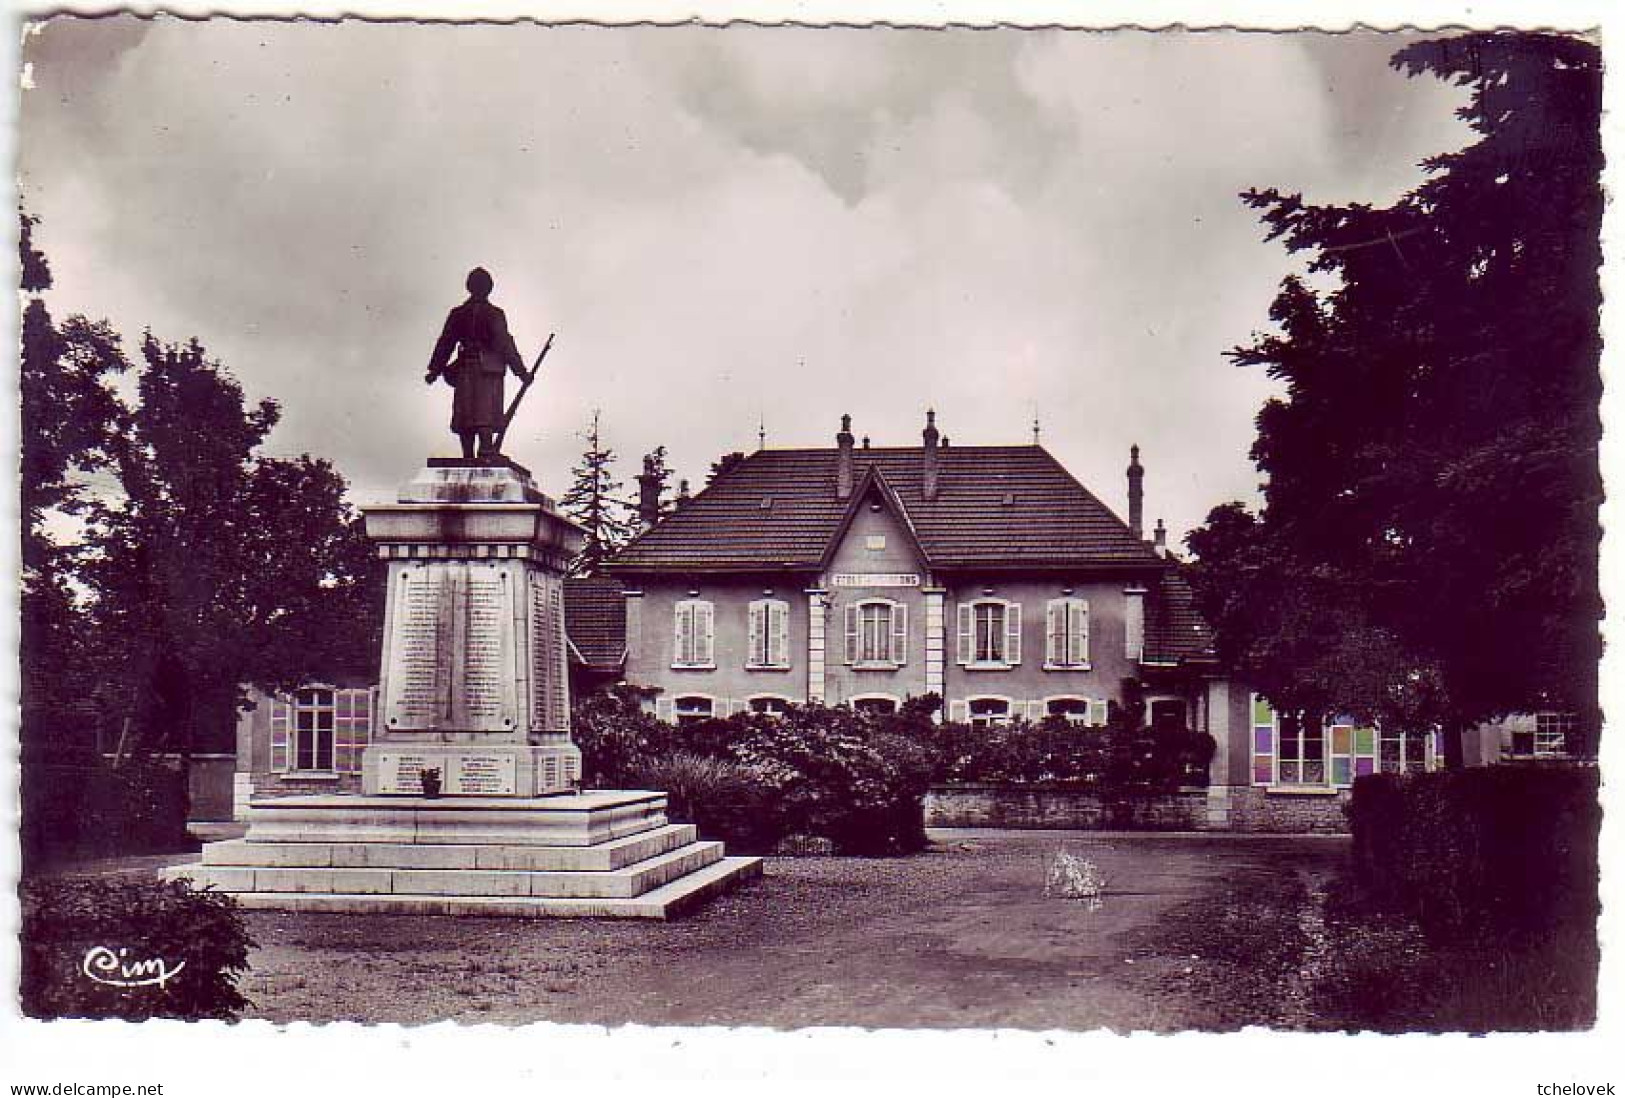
[159, 791, 762, 919]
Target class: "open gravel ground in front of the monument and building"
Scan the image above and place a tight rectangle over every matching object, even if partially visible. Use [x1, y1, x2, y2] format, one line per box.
[225, 832, 1347, 1031]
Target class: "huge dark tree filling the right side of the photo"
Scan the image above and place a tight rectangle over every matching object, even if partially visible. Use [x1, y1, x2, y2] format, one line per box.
[1188, 32, 1602, 762]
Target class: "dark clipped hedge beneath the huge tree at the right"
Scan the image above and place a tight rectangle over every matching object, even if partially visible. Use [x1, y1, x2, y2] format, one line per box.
[1349, 767, 1602, 937]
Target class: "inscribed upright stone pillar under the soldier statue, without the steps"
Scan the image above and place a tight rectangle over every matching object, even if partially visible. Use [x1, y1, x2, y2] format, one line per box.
[361, 460, 582, 798]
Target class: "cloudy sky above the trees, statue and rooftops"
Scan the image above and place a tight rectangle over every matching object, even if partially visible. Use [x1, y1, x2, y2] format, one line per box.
[20, 18, 1469, 538]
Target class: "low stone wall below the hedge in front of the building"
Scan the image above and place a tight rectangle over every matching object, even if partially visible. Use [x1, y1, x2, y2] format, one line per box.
[925, 785, 1349, 835]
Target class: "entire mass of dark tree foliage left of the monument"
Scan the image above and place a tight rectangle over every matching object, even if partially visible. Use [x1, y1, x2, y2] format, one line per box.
[21, 218, 382, 755]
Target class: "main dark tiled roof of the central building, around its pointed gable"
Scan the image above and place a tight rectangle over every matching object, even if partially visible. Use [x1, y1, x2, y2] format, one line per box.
[609, 447, 1160, 573]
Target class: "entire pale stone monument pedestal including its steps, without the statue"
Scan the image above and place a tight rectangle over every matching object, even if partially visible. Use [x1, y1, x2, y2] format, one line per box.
[161, 460, 762, 919]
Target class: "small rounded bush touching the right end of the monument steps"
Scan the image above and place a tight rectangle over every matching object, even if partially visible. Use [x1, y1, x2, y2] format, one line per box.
[632, 750, 783, 854]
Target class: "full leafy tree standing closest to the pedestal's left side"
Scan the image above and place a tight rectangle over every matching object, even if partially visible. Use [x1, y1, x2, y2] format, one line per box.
[80, 335, 377, 759]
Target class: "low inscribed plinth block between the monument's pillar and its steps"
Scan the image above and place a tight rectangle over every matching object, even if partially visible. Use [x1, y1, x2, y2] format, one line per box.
[361, 739, 582, 798]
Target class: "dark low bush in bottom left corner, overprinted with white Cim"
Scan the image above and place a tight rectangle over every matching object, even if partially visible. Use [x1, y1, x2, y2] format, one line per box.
[21, 877, 255, 1022]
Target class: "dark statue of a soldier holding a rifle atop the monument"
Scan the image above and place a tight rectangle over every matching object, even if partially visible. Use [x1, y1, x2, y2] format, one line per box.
[424, 266, 530, 460]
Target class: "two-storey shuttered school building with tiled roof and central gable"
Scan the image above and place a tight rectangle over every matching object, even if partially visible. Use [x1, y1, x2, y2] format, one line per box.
[608, 414, 1222, 740]
